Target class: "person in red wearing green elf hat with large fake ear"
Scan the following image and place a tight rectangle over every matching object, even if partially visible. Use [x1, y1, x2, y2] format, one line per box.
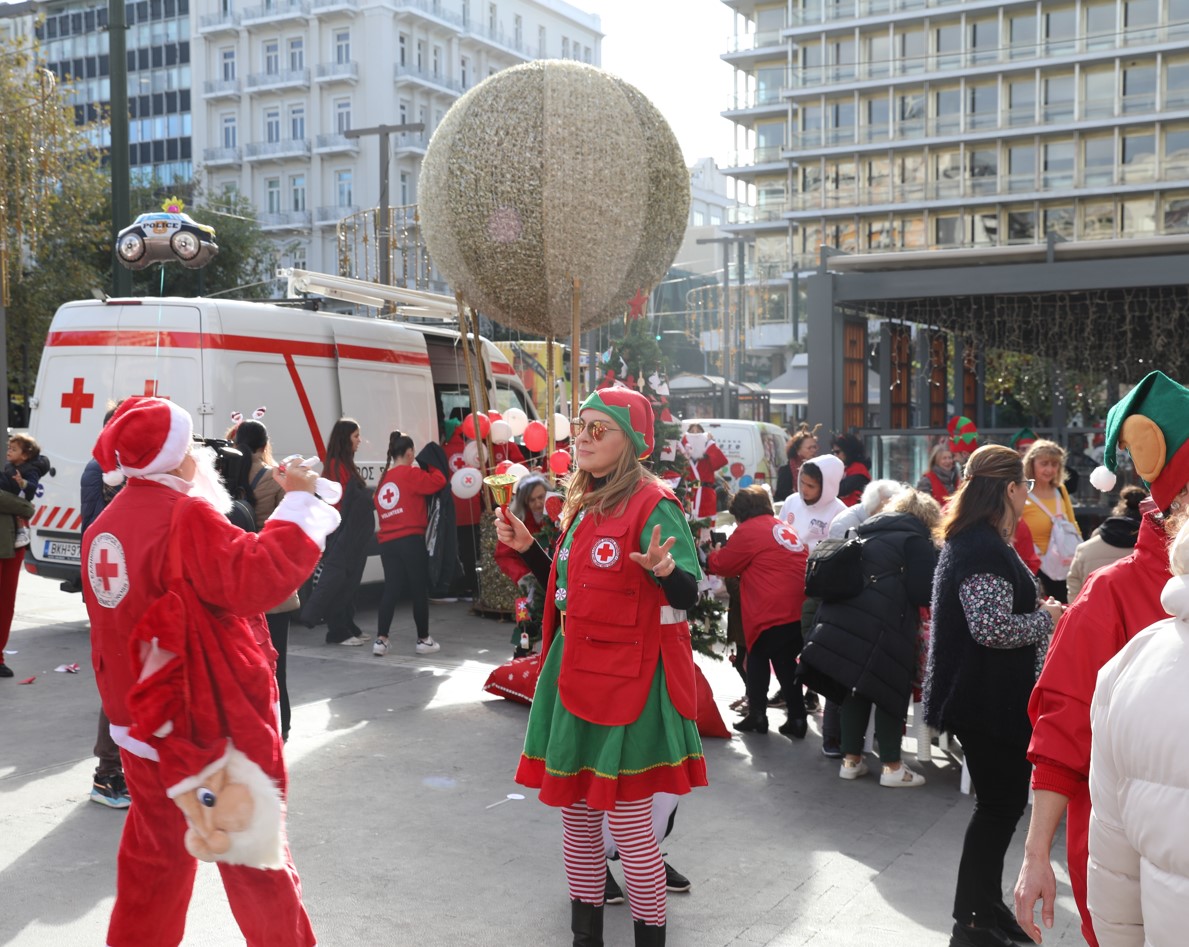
[1015, 371, 1189, 947]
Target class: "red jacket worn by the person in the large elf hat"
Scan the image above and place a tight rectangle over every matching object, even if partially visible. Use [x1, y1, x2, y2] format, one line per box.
[1028, 513, 1169, 934]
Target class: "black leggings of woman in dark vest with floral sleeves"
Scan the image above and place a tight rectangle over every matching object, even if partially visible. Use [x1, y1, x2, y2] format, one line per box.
[954, 729, 1032, 927]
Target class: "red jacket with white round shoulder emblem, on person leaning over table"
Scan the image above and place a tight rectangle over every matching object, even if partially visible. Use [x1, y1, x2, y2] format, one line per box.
[706, 516, 809, 648]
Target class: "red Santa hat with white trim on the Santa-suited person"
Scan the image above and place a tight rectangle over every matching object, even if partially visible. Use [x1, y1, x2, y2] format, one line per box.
[92, 397, 194, 487]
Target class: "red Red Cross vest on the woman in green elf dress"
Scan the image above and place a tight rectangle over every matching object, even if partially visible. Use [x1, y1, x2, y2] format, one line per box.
[541, 483, 698, 727]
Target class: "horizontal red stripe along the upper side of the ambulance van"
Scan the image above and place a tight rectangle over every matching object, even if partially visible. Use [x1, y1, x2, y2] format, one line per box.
[45, 330, 429, 365]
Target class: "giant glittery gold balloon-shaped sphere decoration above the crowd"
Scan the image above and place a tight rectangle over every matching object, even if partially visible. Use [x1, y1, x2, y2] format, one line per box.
[420, 59, 690, 337]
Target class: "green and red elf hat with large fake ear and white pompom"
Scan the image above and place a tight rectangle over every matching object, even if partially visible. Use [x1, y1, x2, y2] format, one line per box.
[1090, 371, 1189, 509]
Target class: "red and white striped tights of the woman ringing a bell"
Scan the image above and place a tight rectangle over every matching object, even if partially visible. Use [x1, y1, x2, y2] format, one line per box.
[561, 797, 665, 927]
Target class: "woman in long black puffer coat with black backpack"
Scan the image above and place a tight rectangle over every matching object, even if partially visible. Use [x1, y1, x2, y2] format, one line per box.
[800, 487, 942, 789]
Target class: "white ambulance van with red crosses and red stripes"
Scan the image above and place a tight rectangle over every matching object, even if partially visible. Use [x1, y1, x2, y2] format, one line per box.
[25, 297, 536, 579]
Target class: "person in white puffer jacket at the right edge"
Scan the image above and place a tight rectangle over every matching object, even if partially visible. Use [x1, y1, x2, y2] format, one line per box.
[1087, 521, 1189, 947]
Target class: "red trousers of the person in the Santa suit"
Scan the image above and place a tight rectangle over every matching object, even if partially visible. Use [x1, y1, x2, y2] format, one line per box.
[107, 751, 316, 947]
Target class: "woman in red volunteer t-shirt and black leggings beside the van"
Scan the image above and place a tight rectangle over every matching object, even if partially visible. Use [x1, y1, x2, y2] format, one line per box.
[372, 431, 446, 658]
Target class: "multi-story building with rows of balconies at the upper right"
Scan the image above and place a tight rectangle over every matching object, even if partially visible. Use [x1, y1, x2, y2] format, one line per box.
[723, 0, 1189, 347]
